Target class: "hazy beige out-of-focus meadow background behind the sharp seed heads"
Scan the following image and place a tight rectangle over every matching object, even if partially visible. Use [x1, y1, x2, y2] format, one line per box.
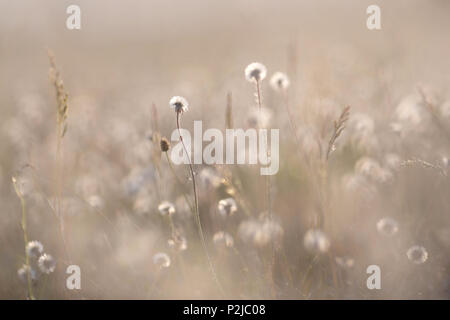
[0, 0, 450, 299]
